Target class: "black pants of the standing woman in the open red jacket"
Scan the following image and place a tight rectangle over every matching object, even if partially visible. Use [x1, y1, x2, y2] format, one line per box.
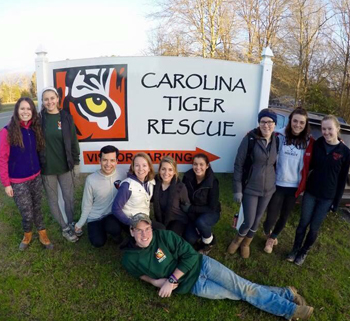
[264, 186, 297, 238]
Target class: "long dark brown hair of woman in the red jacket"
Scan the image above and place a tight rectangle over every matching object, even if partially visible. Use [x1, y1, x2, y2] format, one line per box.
[285, 107, 310, 149]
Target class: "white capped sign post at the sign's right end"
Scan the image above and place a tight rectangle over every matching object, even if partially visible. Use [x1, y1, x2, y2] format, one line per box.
[258, 47, 273, 112]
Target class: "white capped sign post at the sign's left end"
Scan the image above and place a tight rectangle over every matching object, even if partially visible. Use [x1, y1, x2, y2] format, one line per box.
[35, 45, 49, 110]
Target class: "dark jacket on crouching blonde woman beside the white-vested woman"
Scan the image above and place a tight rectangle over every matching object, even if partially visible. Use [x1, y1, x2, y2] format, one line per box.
[153, 175, 190, 227]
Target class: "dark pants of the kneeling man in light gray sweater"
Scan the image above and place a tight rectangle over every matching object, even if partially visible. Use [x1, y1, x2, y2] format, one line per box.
[88, 214, 121, 247]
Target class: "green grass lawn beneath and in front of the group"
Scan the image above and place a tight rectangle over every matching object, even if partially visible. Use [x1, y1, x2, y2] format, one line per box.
[0, 174, 350, 321]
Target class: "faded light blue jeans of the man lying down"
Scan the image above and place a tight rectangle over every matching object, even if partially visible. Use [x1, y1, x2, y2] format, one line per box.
[191, 255, 297, 319]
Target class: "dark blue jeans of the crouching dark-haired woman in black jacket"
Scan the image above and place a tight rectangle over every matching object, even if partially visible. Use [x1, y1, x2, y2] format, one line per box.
[185, 212, 220, 245]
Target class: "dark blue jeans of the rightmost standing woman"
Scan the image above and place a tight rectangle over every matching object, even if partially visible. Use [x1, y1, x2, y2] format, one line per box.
[293, 192, 333, 253]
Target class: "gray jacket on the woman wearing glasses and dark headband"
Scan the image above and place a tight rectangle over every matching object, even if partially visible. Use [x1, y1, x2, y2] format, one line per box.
[233, 129, 277, 196]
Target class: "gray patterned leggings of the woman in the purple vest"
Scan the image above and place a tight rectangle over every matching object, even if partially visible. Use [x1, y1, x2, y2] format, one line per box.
[11, 175, 45, 232]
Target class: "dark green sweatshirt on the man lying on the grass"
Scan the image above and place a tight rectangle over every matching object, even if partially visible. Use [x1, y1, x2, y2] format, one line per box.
[122, 230, 203, 293]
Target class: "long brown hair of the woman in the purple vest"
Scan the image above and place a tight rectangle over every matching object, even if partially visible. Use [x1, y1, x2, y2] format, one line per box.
[7, 97, 45, 151]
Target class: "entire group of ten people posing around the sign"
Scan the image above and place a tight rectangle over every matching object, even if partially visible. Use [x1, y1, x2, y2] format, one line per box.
[0, 87, 350, 320]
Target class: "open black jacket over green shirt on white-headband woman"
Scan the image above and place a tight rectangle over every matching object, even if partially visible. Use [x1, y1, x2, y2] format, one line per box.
[40, 109, 80, 170]
